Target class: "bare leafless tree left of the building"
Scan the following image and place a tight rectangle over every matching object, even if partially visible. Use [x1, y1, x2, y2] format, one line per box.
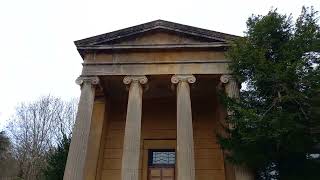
[8, 96, 76, 180]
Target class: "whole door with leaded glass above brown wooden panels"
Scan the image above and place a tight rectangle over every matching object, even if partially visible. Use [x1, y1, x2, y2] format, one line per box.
[148, 149, 176, 180]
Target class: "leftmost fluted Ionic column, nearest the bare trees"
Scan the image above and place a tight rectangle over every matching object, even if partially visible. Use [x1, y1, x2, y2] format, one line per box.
[63, 77, 99, 180]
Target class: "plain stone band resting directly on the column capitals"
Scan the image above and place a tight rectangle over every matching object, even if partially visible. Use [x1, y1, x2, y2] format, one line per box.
[82, 60, 230, 76]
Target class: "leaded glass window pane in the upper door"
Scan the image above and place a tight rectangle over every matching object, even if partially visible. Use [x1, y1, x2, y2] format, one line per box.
[149, 150, 176, 165]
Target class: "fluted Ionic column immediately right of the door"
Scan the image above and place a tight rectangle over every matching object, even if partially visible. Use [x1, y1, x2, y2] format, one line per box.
[171, 75, 196, 180]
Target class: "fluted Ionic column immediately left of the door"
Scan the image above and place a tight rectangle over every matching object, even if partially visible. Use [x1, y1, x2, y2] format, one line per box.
[121, 76, 148, 180]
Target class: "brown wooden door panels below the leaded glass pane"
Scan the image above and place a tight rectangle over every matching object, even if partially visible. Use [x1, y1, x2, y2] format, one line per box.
[148, 167, 175, 180]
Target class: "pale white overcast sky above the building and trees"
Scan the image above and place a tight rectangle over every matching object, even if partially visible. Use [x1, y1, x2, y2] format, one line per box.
[0, 0, 320, 130]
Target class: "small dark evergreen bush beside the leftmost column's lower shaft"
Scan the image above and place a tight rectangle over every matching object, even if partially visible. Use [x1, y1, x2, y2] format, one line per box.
[43, 135, 71, 180]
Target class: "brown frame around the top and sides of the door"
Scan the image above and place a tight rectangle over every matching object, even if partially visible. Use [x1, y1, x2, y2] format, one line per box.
[142, 139, 177, 180]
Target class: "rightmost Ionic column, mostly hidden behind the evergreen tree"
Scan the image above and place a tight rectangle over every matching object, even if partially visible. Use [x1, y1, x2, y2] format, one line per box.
[220, 75, 254, 180]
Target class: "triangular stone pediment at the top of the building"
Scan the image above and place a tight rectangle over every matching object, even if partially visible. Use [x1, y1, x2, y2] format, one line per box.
[75, 20, 237, 48]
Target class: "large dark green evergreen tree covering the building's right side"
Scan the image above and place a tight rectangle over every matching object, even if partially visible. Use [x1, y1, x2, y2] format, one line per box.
[219, 7, 320, 180]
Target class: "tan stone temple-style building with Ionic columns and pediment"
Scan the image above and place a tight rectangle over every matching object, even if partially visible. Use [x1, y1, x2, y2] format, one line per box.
[64, 20, 252, 180]
